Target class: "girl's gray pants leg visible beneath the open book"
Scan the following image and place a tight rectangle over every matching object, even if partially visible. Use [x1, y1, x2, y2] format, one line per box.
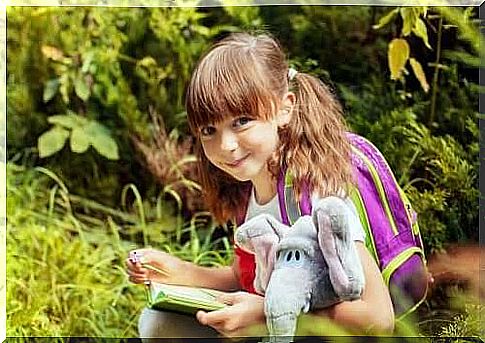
[138, 308, 219, 342]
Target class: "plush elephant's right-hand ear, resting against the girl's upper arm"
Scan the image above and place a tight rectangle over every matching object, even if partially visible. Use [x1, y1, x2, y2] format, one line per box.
[312, 197, 355, 297]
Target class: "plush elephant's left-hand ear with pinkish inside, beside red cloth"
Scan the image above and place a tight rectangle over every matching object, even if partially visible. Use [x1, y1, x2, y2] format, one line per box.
[235, 214, 289, 294]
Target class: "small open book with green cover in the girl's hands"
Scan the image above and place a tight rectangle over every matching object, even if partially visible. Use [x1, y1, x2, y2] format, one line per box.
[146, 283, 226, 314]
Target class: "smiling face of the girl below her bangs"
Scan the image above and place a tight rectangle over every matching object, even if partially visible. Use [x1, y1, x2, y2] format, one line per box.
[200, 117, 278, 183]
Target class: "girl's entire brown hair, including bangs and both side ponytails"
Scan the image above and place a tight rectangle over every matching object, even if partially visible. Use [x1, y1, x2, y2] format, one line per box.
[186, 33, 352, 222]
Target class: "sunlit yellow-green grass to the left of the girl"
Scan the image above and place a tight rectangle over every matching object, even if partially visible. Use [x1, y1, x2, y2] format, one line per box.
[7, 164, 232, 337]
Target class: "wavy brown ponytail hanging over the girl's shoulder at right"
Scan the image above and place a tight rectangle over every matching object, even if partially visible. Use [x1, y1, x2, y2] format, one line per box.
[280, 73, 353, 202]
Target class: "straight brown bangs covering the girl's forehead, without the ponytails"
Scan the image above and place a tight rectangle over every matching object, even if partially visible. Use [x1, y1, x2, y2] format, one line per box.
[186, 46, 279, 135]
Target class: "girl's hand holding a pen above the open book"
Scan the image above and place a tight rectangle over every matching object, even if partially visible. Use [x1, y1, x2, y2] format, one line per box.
[125, 249, 194, 285]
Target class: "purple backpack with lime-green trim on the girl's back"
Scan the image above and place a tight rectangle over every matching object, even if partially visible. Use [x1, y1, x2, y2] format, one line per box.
[278, 133, 429, 318]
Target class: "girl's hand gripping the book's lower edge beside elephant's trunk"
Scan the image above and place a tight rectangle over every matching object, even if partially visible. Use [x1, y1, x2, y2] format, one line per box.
[196, 292, 267, 337]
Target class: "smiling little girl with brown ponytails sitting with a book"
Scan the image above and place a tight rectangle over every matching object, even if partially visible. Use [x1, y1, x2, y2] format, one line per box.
[126, 33, 394, 337]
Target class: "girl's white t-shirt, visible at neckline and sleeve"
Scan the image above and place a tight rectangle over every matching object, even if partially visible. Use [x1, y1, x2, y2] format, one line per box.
[245, 188, 365, 242]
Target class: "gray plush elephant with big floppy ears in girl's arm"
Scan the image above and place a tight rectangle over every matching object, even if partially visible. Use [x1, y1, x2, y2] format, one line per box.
[235, 197, 364, 340]
